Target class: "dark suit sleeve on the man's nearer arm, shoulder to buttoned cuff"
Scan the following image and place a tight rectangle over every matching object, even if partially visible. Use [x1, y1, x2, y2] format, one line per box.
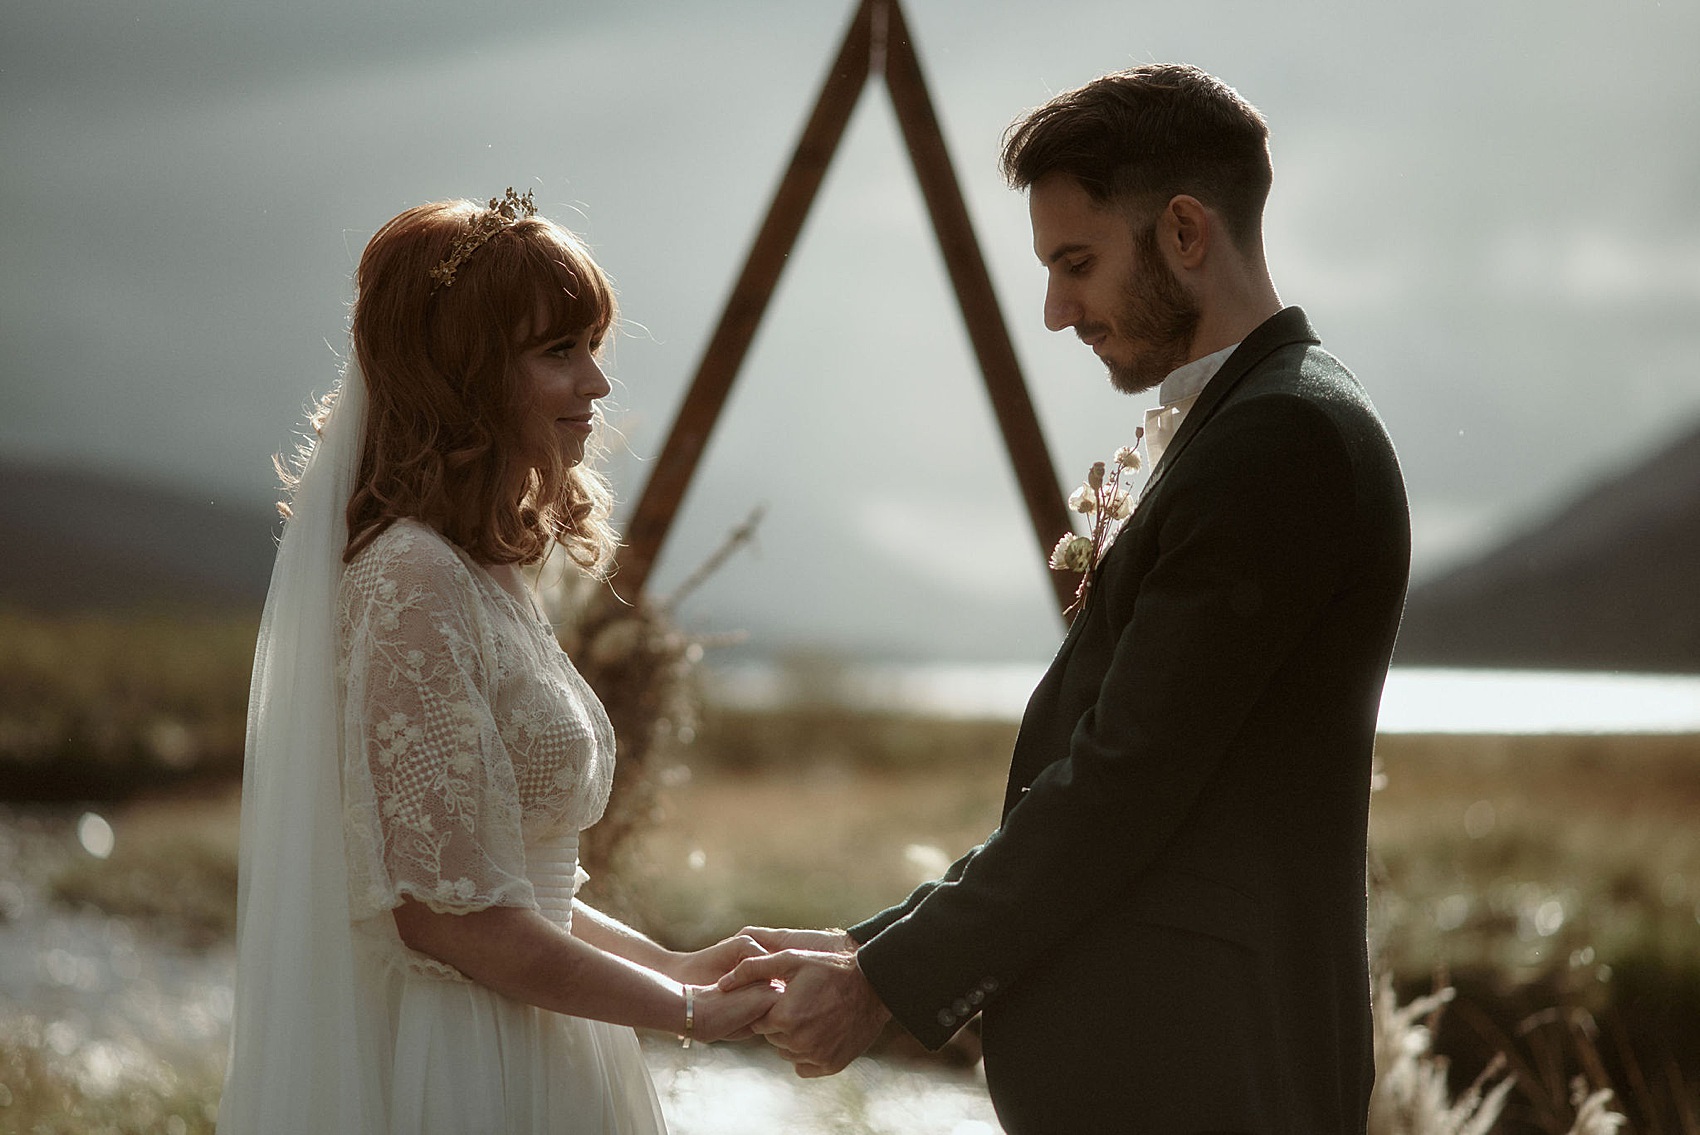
[859, 394, 1355, 1047]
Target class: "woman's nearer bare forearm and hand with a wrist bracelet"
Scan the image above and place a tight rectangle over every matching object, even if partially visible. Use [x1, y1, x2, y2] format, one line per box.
[393, 899, 779, 1040]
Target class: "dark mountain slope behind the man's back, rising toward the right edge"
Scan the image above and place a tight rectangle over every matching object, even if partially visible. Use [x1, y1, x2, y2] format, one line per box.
[1394, 430, 1700, 673]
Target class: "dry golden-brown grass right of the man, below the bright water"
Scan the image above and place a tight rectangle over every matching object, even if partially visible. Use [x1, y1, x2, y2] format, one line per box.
[1370, 736, 1700, 1135]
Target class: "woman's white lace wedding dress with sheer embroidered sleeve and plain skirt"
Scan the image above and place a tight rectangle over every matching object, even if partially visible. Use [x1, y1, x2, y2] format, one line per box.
[338, 522, 665, 1135]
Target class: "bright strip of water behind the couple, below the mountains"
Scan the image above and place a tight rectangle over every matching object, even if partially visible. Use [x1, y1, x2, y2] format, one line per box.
[706, 663, 1700, 734]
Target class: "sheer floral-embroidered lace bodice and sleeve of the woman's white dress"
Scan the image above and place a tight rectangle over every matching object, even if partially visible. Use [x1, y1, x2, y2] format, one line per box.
[338, 522, 614, 937]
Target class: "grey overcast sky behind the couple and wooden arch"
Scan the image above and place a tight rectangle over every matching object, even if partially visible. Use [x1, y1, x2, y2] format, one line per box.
[0, 0, 1700, 659]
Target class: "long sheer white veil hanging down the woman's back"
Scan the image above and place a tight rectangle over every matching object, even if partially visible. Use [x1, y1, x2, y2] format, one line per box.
[218, 368, 388, 1135]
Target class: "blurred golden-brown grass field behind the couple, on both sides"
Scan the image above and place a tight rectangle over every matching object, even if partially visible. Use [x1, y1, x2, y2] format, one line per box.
[0, 615, 1700, 1135]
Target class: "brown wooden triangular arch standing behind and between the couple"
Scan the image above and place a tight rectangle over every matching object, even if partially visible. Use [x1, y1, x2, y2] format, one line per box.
[614, 0, 1074, 610]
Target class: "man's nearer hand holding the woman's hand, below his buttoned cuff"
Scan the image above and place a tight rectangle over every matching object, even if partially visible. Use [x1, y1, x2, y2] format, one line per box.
[719, 935, 891, 1077]
